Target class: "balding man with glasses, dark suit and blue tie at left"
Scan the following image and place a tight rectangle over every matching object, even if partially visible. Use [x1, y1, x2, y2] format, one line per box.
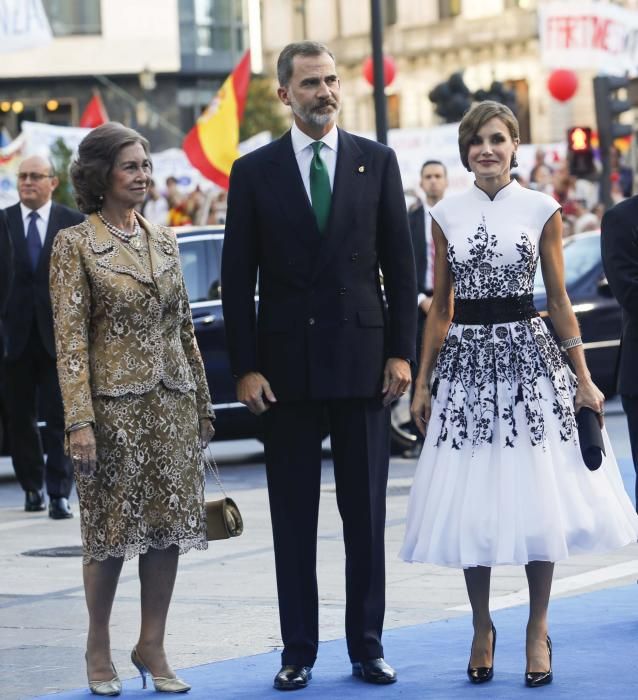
[3, 156, 84, 520]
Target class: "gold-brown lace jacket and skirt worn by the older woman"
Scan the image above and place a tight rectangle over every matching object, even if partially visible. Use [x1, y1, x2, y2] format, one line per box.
[50, 214, 214, 563]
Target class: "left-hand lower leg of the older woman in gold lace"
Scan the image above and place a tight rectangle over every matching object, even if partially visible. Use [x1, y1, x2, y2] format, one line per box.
[82, 557, 124, 681]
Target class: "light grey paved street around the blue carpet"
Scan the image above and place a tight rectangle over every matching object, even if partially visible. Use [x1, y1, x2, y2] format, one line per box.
[0, 402, 638, 700]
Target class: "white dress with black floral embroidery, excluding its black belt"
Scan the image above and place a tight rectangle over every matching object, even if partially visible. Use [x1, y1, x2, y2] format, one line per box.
[401, 181, 638, 568]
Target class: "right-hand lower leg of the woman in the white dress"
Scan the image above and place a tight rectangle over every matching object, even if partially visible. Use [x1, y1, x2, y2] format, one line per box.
[525, 561, 554, 673]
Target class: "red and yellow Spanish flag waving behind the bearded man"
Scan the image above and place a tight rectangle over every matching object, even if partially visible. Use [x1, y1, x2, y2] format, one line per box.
[182, 51, 250, 190]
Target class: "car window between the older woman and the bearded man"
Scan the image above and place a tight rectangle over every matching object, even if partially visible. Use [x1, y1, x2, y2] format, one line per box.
[179, 239, 222, 303]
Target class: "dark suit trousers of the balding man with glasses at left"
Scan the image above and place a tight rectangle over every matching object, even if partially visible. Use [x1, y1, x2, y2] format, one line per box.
[5, 322, 73, 498]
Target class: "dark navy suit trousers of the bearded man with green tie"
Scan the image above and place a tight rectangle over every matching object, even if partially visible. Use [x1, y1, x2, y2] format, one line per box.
[264, 398, 390, 666]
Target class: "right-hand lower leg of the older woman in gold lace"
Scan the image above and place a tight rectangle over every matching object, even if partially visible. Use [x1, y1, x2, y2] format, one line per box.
[137, 545, 179, 678]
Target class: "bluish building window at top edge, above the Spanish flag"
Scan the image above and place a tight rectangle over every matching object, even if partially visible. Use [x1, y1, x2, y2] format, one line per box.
[195, 0, 245, 56]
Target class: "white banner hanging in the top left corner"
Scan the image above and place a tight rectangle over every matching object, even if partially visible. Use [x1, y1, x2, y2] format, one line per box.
[0, 0, 53, 53]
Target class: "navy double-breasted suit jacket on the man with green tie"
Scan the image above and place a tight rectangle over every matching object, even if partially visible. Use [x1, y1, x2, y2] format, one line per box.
[222, 129, 416, 401]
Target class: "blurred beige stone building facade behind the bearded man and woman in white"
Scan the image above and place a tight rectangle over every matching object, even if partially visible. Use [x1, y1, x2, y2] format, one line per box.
[263, 0, 636, 143]
